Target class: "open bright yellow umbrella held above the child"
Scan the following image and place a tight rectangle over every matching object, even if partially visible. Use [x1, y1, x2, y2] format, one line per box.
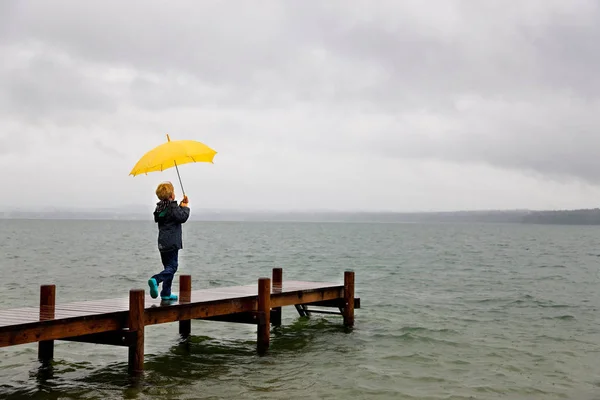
[129, 134, 217, 196]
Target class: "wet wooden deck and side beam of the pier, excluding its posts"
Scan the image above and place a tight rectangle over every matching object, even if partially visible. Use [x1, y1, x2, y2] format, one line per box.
[0, 281, 344, 347]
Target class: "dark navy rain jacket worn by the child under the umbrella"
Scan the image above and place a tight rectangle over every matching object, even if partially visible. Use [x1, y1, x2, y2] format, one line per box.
[154, 201, 190, 253]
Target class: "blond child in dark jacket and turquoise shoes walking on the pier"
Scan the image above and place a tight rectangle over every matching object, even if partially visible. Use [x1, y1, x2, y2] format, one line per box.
[148, 182, 190, 301]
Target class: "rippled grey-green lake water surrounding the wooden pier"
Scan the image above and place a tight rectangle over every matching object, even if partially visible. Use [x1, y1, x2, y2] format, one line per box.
[0, 220, 600, 399]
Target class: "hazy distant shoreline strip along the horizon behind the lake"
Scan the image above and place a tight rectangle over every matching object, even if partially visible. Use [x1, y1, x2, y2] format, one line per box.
[0, 208, 600, 225]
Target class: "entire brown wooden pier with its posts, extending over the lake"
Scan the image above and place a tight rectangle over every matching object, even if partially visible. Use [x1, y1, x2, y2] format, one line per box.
[0, 268, 360, 374]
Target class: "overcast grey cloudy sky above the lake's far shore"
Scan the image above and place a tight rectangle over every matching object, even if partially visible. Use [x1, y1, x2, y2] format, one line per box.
[0, 0, 600, 211]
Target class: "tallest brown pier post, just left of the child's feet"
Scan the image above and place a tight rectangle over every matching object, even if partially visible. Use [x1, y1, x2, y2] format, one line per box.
[127, 289, 145, 374]
